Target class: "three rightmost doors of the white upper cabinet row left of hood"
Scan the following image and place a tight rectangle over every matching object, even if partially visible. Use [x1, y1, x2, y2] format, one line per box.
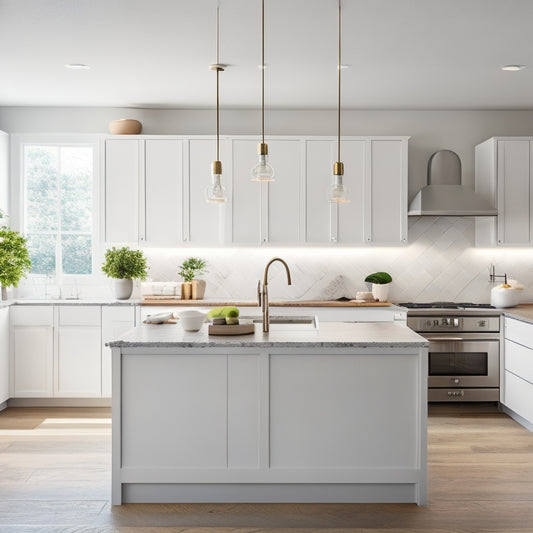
[305, 137, 408, 245]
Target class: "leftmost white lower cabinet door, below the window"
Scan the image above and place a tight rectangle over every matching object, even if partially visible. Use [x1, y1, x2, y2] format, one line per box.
[10, 306, 54, 398]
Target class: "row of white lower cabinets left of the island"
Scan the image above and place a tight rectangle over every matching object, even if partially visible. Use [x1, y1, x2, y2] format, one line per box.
[9, 304, 136, 403]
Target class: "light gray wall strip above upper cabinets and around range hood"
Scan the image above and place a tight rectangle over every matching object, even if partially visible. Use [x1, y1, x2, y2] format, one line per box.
[0, 107, 533, 199]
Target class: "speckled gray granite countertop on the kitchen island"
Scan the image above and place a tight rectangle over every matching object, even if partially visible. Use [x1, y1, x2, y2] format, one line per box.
[109, 322, 428, 348]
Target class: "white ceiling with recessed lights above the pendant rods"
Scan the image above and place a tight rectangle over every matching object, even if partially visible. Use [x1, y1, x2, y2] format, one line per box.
[0, 0, 533, 109]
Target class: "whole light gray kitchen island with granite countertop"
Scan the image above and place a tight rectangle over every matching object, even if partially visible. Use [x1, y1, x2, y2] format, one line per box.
[109, 323, 427, 505]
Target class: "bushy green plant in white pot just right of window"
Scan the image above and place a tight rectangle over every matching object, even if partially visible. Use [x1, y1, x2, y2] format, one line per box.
[102, 246, 147, 300]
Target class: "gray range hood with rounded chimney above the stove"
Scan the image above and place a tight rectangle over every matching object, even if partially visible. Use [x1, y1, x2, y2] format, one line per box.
[407, 150, 498, 217]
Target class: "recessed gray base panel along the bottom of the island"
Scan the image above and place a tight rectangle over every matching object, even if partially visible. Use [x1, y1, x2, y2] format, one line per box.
[122, 483, 420, 503]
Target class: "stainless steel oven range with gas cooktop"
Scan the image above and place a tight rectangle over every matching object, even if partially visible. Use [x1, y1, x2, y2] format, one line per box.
[407, 310, 500, 402]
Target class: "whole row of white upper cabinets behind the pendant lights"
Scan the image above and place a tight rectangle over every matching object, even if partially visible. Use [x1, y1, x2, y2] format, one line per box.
[105, 136, 408, 246]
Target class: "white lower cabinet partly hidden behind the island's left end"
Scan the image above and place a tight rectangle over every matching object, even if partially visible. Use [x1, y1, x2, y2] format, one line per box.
[102, 306, 135, 398]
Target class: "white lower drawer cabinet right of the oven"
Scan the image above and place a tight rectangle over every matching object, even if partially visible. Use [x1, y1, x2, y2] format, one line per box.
[503, 318, 533, 425]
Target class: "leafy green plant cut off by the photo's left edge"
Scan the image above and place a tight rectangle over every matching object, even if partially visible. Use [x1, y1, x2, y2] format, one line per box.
[0, 226, 31, 300]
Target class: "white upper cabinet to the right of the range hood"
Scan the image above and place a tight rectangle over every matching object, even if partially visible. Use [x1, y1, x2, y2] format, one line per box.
[475, 137, 533, 246]
